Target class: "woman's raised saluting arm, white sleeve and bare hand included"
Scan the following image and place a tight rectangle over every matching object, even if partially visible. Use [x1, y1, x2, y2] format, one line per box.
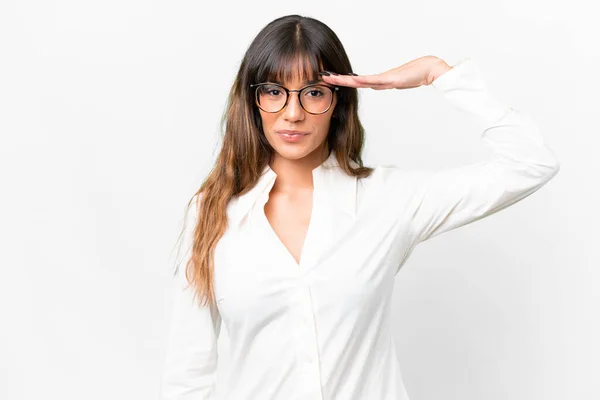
[323, 56, 560, 246]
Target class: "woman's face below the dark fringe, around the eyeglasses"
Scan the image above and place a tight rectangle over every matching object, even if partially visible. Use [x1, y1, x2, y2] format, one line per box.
[259, 73, 337, 160]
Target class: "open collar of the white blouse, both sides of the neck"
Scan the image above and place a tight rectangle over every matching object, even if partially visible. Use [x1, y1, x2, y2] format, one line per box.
[232, 150, 358, 225]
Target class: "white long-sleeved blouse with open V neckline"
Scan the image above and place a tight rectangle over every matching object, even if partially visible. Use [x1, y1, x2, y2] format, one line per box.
[161, 58, 559, 400]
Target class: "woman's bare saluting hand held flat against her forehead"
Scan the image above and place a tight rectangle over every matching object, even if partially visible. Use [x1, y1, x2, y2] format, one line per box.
[321, 56, 452, 90]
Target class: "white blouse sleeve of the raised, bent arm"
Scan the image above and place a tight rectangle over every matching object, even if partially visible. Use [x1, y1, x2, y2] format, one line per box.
[407, 58, 560, 244]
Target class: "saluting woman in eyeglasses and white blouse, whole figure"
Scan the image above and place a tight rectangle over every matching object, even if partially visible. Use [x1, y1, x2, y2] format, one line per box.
[161, 15, 559, 400]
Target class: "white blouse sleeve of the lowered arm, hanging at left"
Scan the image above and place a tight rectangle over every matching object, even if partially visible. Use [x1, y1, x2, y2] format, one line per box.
[160, 192, 221, 400]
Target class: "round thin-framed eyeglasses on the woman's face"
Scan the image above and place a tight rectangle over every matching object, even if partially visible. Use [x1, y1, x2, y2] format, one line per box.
[250, 82, 339, 114]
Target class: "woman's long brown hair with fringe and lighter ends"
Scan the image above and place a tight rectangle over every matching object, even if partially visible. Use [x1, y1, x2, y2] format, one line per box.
[171, 15, 373, 305]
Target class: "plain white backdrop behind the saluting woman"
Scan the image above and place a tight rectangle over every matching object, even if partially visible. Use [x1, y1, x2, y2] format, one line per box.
[0, 0, 600, 400]
